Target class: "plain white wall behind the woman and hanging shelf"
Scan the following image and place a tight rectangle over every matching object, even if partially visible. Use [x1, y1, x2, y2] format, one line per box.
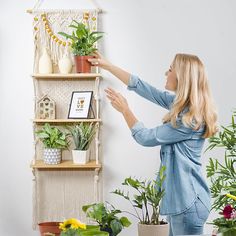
[0, 0, 236, 236]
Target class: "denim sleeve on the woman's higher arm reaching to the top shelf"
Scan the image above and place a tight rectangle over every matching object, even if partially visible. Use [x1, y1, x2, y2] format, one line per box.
[127, 75, 175, 110]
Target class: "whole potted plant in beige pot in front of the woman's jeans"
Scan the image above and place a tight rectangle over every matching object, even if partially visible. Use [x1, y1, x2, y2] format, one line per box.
[113, 166, 169, 236]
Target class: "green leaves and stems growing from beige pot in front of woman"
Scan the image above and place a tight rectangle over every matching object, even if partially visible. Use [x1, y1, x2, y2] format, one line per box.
[113, 166, 166, 225]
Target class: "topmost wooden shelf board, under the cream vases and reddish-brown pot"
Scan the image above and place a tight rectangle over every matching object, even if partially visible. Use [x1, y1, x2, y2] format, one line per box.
[32, 73, 102, 80]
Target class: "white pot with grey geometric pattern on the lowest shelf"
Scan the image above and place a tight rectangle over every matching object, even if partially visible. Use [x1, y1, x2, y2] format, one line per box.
[43, 148, 61, 165]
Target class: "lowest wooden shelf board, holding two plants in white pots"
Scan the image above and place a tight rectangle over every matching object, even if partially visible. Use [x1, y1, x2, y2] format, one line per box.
[30, 160, 102, 170]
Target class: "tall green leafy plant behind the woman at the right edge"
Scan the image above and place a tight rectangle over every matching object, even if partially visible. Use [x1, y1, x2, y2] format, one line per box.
[206, 109, 236, 210]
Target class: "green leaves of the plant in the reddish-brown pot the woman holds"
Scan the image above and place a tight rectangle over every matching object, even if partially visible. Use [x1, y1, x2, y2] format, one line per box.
[58, 20, 103, 56]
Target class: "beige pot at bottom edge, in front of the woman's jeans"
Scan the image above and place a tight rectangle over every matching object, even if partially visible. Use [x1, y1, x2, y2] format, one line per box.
[138, 224, 169, 236]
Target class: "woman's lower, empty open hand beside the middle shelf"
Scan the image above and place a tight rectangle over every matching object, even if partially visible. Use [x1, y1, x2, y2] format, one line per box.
[105, 88, 129, 114]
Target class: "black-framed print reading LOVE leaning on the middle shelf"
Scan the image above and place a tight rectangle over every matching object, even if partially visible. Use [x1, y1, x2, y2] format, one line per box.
[68, 91, 93, 119]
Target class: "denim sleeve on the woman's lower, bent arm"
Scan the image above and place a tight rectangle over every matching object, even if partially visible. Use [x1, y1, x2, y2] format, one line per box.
[131, 121, 193, 147]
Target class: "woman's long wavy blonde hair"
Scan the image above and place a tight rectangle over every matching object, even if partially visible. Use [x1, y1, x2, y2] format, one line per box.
[163, 54, 217, 138]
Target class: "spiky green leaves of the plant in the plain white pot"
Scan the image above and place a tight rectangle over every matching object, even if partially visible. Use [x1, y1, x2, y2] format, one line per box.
[67, 122, 97, 150]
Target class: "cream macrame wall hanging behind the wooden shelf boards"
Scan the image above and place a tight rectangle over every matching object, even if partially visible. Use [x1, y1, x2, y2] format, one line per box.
[27, 0, 104, 228]
